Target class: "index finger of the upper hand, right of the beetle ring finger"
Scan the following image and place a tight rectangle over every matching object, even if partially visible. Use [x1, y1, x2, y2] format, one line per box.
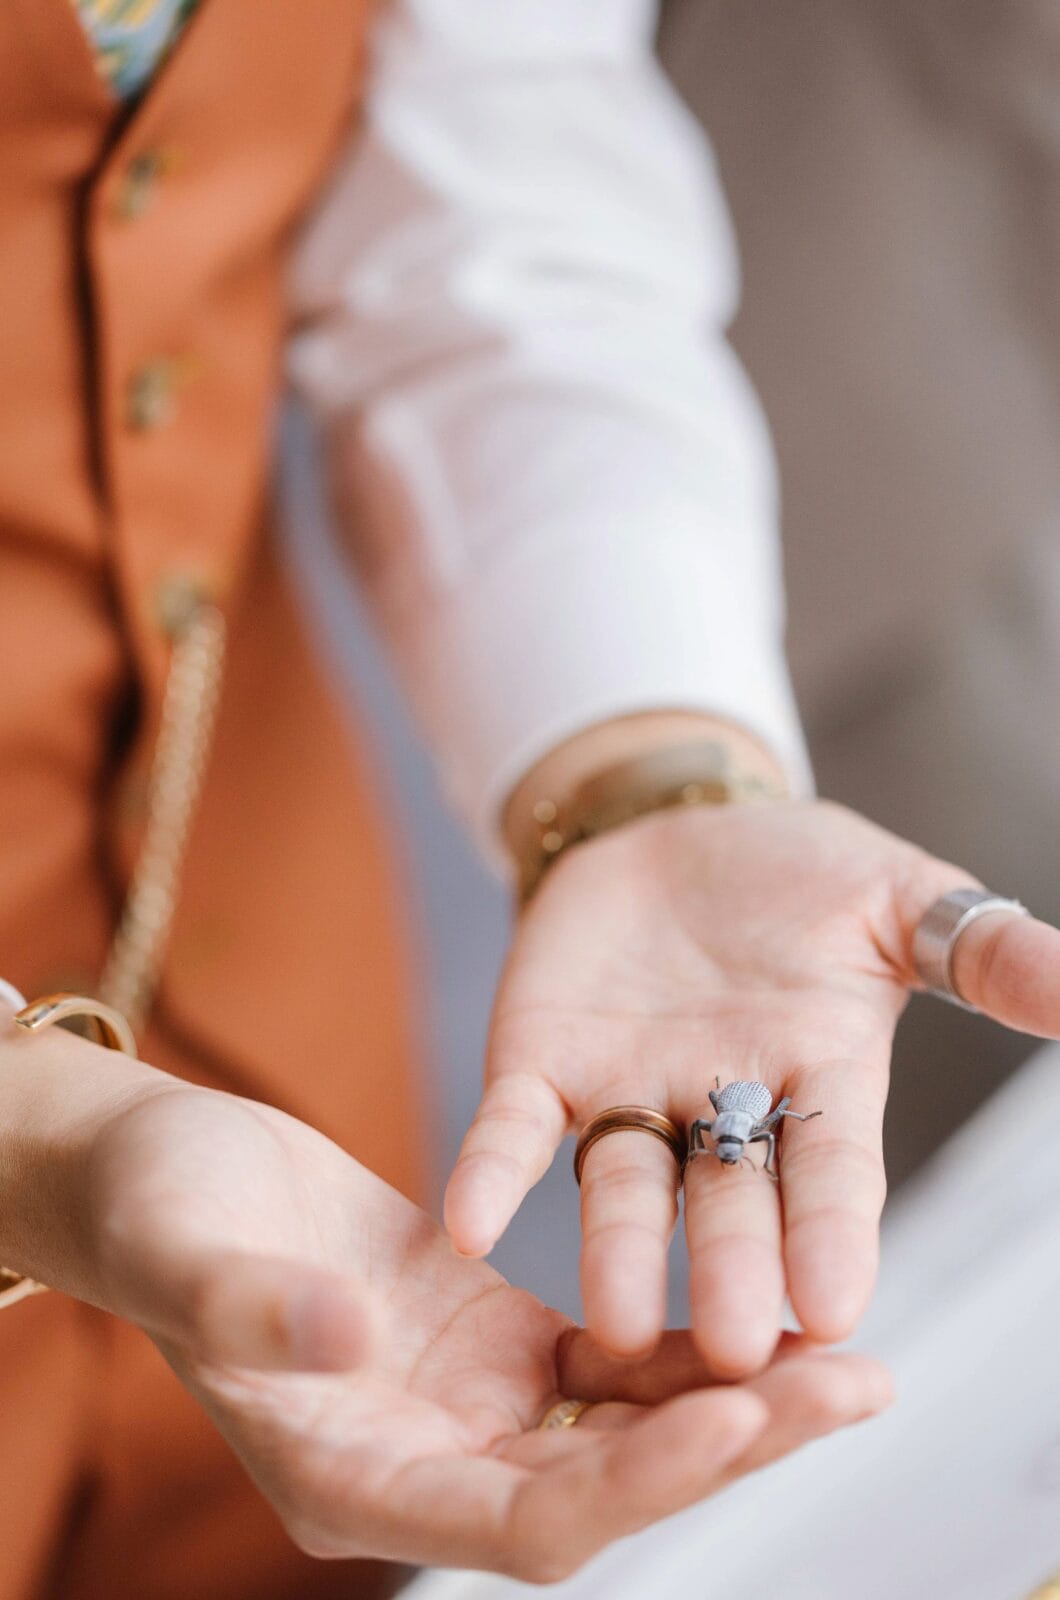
[778, 1051, 887, 1342]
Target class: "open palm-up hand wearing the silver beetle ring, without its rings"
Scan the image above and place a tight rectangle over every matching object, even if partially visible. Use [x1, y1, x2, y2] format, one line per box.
[445, 802, 1060, 1376]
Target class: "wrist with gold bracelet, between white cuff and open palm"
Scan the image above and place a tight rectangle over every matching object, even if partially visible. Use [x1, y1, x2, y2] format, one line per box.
[503, 712, 788, 899]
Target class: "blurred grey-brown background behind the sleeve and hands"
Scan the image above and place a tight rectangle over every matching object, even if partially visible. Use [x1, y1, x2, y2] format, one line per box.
[285, 0, 1060, 1317]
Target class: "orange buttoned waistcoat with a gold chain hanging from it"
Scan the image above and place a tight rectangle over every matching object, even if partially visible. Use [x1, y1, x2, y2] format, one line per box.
[0, 0, 432, 1190]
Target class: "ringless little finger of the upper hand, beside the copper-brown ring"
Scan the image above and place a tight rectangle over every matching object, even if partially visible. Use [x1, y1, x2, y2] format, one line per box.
[445, 1072, 570, 1256]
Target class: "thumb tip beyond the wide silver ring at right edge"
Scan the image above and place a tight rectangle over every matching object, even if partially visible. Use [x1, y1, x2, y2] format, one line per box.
[953, 910, 1060, 1038]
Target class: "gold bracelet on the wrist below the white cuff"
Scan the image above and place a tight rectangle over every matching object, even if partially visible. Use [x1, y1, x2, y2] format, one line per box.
[519, 739, 789, 906]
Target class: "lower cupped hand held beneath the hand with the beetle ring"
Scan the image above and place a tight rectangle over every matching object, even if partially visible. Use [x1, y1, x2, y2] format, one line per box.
[70, 1085, 889, 1581]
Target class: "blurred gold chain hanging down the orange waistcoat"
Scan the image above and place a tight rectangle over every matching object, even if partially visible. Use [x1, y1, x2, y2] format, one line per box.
[99, 602, 226, 1027]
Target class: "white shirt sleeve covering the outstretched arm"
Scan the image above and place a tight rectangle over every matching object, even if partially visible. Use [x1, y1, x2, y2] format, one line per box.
[290, 0, 809, 853]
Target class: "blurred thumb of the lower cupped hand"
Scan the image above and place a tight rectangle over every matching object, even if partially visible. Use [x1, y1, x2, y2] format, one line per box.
[118, 1251, 381, 1373]
